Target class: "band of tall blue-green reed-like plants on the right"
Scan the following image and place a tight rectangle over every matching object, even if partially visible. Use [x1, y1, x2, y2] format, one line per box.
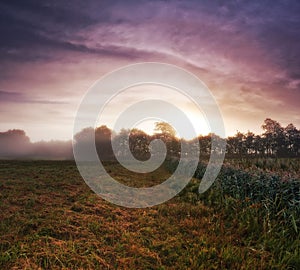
[166, 161, 300, 235]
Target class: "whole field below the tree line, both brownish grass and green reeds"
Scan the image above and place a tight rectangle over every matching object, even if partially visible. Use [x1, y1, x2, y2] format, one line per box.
[0, 159, 300, 269]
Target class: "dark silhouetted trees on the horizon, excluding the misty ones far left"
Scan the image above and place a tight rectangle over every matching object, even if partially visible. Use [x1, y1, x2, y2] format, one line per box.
[75, 118, 300, 160]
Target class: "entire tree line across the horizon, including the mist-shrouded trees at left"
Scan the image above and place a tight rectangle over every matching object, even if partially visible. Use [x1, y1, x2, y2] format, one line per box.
[0, 118, 300, 160]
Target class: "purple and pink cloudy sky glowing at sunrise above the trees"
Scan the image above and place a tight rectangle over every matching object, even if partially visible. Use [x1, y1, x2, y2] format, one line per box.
[0, 0, 300, 141]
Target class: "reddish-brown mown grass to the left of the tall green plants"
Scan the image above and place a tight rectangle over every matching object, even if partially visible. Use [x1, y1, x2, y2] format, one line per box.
[0, 161, 296, 269]
